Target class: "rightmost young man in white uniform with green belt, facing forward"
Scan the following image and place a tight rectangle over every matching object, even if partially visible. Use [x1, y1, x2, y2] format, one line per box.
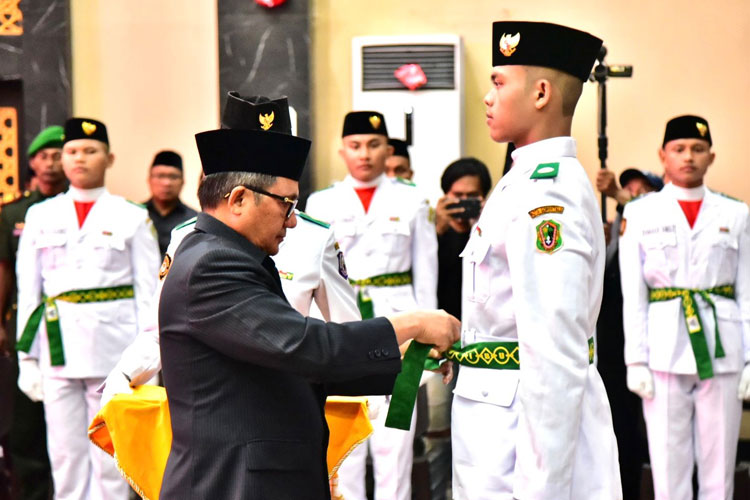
[620, 115, 750, 499]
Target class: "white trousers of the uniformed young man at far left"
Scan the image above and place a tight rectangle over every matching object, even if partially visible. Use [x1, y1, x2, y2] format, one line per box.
[43, 376, 130, 500]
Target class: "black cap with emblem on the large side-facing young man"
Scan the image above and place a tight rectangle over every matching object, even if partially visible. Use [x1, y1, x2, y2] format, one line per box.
[492, 21, 602, 82]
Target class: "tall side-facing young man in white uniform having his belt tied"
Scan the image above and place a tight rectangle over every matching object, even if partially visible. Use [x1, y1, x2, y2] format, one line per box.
[452, 21, 622, 500]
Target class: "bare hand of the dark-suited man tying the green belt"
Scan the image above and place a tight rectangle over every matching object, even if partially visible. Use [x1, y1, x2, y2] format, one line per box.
[388, 310, 461, 352]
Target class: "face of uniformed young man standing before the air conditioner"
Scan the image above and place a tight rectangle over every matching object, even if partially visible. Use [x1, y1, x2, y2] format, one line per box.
[339, 134, 393, 182]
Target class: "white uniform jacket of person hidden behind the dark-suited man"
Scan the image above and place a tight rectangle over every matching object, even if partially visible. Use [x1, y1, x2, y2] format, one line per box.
[118, 213, 362, 385]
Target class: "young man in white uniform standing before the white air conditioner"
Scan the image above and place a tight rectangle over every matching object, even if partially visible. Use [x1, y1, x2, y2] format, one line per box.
[306, 111, 437, 500]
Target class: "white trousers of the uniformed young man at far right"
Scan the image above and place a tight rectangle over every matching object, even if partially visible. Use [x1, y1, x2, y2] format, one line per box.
[643, 371, 742, 500]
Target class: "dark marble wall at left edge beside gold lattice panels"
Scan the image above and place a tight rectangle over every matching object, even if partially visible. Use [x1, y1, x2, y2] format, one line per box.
[0, 0, 72, 186]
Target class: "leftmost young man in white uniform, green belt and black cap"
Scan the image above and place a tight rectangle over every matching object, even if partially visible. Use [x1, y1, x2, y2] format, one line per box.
[16, 118, 159, 500]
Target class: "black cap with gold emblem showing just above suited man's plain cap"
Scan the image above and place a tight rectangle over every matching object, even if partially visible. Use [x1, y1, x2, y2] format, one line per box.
[221, 90, 292, 135]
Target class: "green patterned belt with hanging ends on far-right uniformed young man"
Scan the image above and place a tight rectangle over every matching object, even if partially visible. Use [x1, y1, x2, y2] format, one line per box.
[648, 285, 734, 380]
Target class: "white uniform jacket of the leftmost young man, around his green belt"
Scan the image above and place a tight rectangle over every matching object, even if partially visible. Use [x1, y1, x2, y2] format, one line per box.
[16, 190, 159, 378]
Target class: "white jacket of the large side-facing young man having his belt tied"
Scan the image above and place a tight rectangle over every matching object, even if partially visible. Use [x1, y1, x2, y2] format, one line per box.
[454, 137, 621, 500]
